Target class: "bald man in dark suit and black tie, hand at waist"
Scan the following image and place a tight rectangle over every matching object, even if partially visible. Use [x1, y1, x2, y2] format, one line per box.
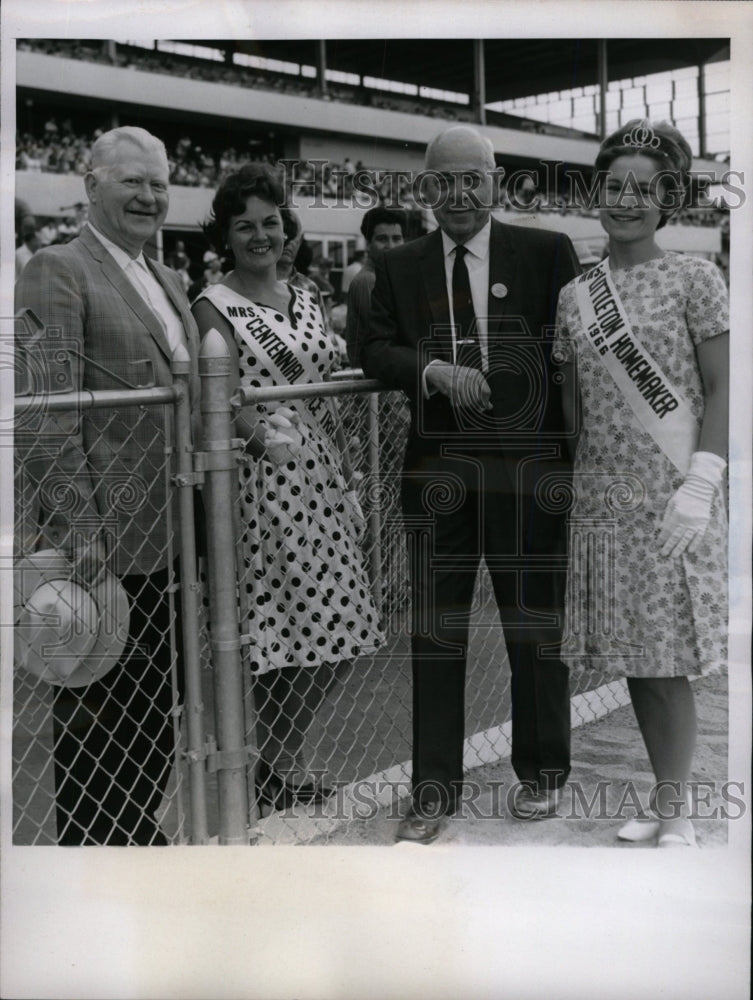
[362, 125, 578, 843]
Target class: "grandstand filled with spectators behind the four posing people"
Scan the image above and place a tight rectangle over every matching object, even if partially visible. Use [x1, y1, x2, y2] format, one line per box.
[16, 39, 729, 289]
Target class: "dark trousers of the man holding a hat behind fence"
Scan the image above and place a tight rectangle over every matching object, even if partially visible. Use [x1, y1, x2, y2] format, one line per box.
[53, 569, 183, 846]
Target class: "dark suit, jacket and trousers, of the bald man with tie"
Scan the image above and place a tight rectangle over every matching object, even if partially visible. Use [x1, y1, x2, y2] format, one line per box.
[362, 220, 578, 812]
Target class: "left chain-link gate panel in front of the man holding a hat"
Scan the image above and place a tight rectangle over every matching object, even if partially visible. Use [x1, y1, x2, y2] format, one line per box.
[13, 372, 195, 844]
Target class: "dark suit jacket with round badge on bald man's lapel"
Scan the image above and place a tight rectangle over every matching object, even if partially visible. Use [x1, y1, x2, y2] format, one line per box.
[361, 219, 579, 548]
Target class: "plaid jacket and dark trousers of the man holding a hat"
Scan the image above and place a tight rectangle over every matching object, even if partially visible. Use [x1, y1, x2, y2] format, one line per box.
[16, 229, 198, 845]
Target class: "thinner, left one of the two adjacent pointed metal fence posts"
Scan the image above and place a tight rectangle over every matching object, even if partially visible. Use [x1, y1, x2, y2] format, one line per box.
[172, 346, 209, 844]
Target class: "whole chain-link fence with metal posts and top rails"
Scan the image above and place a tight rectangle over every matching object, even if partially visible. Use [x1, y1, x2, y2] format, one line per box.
[13, 320, 624, 844]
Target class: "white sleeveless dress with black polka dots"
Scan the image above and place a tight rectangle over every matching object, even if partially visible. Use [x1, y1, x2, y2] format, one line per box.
[200, 284, 383, 674]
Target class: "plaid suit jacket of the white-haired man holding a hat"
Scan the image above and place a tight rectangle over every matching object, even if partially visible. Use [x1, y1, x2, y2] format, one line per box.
[16, 229, 199, 575]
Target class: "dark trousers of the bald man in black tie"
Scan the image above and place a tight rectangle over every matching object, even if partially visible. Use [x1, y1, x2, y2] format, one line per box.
[402, 453, 570, 812]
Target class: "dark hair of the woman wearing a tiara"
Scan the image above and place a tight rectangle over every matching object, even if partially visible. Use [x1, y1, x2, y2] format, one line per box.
[594, 118, 693, 229]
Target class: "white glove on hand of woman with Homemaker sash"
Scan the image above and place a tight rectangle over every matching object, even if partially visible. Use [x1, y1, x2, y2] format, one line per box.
[657, 451, 727, 559]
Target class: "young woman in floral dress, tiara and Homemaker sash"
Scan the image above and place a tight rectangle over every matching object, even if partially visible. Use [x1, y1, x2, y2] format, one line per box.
[558, 121, 729, 847]
